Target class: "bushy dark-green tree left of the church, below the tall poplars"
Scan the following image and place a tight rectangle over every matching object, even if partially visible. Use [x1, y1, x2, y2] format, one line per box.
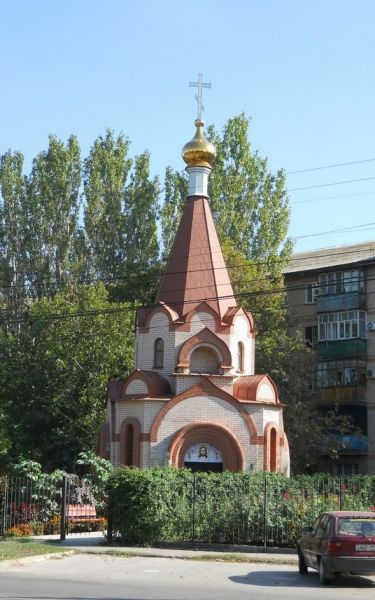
[0, 284, 134, 470]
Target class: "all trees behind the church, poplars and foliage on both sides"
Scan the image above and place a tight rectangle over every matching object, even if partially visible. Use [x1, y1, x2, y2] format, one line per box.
[0, 114, 341, 470]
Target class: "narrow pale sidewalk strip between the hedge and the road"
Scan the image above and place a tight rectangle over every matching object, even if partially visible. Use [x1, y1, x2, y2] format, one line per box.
[34, 532, 298, 565]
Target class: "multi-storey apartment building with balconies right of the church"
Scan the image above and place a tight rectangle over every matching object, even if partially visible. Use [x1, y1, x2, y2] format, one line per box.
[285, 241, 375, 475]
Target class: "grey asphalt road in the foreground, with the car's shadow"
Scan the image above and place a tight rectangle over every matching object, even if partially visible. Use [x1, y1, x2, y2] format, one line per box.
[0, 554, 375, 600]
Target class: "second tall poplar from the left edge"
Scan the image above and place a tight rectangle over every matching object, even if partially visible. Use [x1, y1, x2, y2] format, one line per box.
[25, 135, 81, 298]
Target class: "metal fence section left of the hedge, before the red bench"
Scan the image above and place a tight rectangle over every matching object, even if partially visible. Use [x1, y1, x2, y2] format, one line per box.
[0, 476, 107, 539]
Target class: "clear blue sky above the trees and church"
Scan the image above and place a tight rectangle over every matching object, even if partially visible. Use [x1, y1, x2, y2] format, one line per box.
[0, 0, 375, 251]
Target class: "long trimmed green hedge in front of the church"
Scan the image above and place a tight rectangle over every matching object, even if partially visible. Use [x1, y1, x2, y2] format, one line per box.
[107, 467, 375, 546]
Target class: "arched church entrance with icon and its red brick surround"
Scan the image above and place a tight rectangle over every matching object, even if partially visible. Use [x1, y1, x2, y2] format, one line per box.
[169, 423, 244, 471]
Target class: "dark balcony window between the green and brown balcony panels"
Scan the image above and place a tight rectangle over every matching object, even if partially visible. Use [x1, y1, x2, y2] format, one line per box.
[317, 360, 366, 388]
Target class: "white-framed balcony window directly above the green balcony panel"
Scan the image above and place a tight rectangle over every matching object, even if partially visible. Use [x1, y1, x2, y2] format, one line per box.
[318, 310, 366, 342]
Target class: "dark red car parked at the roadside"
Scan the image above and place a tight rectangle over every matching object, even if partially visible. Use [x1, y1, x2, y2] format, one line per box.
[297, 511, 375, 584]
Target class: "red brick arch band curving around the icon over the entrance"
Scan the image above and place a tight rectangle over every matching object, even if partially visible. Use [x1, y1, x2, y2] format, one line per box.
[169, 422, 245, 472]
